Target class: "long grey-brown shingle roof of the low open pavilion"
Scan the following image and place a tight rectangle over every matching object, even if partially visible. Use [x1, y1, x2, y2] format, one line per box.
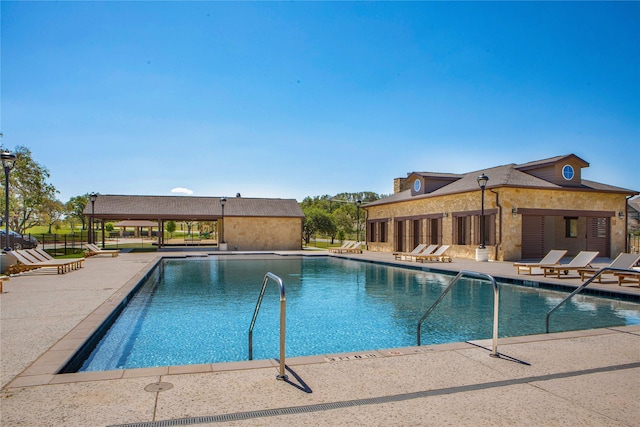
[84, 194, 304, 220]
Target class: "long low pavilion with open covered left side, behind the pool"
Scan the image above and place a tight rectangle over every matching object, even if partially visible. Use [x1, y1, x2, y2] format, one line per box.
[84, 194, 304, 251]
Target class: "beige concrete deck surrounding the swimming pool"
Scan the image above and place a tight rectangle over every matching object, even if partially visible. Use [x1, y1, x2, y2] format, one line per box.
[0, 252, 640, 426]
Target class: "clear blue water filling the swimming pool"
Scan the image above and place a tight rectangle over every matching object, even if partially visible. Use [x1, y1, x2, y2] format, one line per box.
[79, 257, 640, 371]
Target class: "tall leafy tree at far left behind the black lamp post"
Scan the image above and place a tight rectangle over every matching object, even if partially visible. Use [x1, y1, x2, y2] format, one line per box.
[0, 146, 58, 233]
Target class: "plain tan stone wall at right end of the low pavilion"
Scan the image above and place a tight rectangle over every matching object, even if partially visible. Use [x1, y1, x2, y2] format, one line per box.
[224, 216, 302, 251]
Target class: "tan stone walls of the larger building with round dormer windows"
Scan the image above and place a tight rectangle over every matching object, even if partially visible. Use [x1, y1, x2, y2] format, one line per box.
[366, 188, 626, 261]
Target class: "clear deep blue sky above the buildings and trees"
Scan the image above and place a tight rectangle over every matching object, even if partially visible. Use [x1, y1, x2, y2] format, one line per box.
[0, 1, 640, 202]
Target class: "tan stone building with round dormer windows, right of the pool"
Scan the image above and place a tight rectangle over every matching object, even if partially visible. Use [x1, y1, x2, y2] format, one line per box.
[363, 154, 638, 261]
